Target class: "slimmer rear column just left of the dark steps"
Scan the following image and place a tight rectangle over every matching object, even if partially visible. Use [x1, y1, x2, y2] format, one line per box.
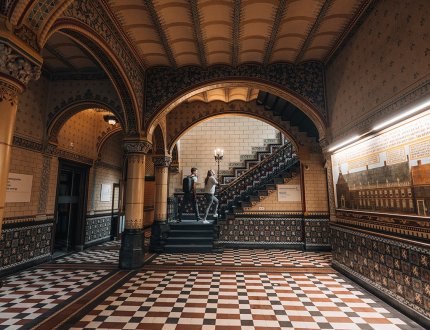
[151, 155, 172, 252]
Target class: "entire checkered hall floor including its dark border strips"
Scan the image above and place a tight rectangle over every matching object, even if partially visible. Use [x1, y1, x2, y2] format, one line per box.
[0, 242, 422, 330]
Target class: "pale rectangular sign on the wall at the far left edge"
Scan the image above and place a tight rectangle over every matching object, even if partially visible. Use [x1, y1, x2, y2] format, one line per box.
[6, 173, 33, 203]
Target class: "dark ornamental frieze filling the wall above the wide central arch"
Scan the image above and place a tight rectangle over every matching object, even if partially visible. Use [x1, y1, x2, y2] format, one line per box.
[145, 62, 327, 120]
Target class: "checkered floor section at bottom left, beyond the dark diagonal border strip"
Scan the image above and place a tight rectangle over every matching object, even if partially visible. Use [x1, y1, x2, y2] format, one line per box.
[0, 269, 108, 329]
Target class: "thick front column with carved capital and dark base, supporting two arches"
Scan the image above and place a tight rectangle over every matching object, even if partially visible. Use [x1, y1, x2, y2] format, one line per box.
[119, 139, 151, 269]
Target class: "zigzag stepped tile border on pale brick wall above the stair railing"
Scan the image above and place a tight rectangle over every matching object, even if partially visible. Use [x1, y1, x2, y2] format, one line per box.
[220, 133, 285, 186]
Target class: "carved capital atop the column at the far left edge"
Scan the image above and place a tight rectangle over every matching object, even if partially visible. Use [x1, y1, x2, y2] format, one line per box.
[0, 41, 41, 86]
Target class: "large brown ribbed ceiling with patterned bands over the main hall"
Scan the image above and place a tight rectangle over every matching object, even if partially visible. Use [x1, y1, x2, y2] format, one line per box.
[107, 0, 372, 67]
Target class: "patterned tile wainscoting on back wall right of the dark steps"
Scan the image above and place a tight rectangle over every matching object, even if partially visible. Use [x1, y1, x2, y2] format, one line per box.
[219, 213, 330, 250]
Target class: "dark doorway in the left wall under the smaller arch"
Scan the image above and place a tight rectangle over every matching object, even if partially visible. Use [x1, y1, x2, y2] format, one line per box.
[54, 160, 88, 255]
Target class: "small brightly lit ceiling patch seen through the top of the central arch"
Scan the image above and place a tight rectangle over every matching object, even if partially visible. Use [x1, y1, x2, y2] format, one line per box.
[187, 87, 259, 103]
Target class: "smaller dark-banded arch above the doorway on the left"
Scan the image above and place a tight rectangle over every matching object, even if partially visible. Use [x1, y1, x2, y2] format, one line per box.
[46, 94, 125, 143]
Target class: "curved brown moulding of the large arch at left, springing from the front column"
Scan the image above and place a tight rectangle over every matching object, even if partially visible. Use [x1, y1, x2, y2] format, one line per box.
[46, 18, 140, 135]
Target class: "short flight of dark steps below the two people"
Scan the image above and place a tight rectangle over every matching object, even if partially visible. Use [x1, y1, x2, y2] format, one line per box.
[164, 220, 215, 253]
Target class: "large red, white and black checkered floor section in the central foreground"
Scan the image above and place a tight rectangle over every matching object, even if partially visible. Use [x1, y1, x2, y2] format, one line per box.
[73, 271, 419, 330]
